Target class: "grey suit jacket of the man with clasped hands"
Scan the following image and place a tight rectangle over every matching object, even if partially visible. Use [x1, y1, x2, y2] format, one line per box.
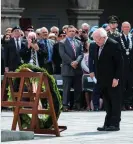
[59, 38, 83, 76]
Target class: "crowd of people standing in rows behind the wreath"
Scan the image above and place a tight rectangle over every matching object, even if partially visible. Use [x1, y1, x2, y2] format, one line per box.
[1, 16, 133, 115]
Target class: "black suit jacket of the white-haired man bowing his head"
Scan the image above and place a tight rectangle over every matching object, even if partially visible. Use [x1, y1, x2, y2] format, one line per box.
[94, 38, 123, 87]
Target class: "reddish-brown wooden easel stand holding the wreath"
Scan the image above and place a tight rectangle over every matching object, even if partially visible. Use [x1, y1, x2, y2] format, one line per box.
[1, 69, 67, 136]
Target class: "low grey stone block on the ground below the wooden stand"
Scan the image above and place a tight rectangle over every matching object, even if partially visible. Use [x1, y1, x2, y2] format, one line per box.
[1, 130, 34, 142]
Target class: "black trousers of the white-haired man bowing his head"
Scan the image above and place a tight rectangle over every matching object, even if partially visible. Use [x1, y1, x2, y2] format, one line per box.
[101, 85, 122, 127]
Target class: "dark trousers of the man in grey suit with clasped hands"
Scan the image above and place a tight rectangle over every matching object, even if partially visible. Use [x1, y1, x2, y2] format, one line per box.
[63, 76, 82, 106]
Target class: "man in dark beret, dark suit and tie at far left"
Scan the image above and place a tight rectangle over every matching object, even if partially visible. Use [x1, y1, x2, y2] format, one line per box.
[4, 26, 23, 72]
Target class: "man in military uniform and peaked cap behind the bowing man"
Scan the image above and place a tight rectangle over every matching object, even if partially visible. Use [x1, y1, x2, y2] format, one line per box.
[107, 15, 120, 39]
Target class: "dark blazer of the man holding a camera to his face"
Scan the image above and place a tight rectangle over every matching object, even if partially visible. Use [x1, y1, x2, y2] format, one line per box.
[20, 41, 45, 67]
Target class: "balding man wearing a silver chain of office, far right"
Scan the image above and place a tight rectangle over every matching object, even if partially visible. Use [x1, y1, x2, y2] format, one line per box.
[119, 21, 133, 110]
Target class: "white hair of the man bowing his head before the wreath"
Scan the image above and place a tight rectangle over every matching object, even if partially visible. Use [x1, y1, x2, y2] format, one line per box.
[92, 28, 107, 37]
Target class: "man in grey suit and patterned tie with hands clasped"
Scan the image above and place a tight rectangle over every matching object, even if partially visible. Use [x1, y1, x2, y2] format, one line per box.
[59, 25, 83, 111]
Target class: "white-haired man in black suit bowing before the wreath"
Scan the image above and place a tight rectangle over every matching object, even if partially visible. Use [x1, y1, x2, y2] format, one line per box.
[93, 28, 123, 131]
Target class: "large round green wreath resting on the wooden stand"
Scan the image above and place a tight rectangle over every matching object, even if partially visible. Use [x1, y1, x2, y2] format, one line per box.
[8, 64, 62, 129]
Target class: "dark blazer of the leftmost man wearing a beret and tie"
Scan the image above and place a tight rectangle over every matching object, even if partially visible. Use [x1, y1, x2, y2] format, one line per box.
[4, 38, 22, 71]
